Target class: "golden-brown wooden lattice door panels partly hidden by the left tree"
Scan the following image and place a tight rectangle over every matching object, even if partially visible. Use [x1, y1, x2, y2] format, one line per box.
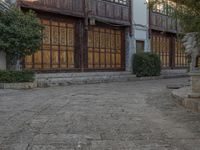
[25, 19, 75, 70]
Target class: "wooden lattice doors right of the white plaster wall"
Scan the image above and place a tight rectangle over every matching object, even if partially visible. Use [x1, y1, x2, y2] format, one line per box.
[151, 33, 188, 68]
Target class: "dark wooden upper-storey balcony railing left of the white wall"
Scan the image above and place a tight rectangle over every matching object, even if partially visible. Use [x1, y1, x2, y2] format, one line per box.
[18, 0, 131, 25]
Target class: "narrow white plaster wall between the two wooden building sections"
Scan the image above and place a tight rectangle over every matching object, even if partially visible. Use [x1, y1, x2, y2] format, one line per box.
[126, 0, 150, 72]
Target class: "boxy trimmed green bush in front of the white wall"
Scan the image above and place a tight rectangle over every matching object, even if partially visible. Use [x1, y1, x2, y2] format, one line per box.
[133, 53, 161, 77]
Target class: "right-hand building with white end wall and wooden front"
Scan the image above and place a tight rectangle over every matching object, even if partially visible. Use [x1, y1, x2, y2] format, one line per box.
[131, 0, 188, 69]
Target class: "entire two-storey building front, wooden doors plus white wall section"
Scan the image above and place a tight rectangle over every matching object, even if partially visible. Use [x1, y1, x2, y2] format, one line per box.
[0, 0, 187, 72]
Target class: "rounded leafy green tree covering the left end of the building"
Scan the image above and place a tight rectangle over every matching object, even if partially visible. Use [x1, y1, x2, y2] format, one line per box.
[0, 7, 43, 68]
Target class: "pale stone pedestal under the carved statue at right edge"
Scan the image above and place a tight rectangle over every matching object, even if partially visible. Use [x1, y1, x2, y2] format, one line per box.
[189, 71, 200, 98]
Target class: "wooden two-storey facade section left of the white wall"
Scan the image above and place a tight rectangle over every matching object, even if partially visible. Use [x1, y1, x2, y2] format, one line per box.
[18, 0, 131, 72]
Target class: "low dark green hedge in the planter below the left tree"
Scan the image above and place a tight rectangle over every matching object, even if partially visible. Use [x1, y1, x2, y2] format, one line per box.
[0, 71, 35, 83]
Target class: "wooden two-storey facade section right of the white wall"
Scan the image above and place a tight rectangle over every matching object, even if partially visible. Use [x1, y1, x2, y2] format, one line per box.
[149, 0, 188, 69]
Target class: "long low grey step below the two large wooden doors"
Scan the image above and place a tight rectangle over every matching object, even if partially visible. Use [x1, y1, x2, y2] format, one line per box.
[36, 72, 136, 87]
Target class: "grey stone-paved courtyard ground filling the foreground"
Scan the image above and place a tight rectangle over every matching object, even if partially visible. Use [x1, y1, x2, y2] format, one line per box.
[0, 78, 200, 150]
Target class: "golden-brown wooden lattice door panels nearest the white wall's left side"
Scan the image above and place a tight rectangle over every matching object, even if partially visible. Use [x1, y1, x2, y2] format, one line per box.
[88, 27, 125, 69]
